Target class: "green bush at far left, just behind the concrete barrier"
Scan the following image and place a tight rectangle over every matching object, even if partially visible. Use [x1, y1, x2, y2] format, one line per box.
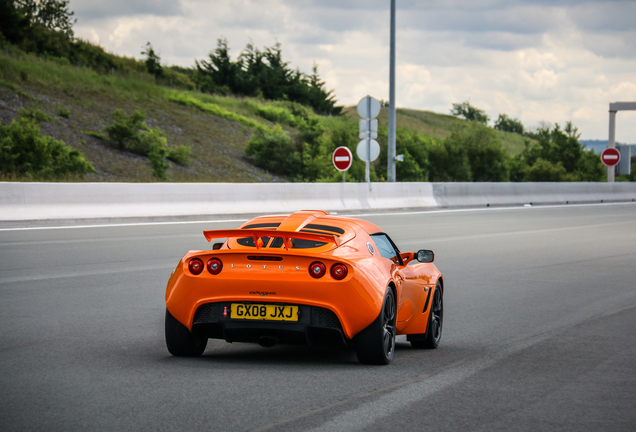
[0, 118, 95, 179]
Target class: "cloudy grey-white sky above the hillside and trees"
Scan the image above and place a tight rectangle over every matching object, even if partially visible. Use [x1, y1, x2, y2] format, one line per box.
[70, 0, 636, 143]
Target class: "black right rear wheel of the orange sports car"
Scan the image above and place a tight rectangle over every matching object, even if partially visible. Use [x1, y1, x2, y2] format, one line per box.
[356, 288, 396, 365]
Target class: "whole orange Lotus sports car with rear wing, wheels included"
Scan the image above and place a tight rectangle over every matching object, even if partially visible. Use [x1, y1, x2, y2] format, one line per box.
[165, 210, 444, 364]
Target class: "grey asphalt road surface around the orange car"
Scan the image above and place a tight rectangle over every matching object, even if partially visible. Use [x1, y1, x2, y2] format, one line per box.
[0, 204, 636, 432]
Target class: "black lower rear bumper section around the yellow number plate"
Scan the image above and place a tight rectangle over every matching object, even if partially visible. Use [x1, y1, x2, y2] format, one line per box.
[192, 302, 348, 345]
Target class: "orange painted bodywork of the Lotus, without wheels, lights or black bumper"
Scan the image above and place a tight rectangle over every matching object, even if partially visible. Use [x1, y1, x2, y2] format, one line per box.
[166, 211, 442, 339]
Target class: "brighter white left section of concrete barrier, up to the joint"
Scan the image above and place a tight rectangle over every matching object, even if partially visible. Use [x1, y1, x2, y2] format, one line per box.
[0, 182, 437, 221]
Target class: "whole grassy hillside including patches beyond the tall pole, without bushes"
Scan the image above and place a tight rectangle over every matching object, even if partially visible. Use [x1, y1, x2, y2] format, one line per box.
[0, 51, 524, 182]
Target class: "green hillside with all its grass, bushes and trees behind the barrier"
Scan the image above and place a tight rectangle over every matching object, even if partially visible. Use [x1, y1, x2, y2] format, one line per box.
[0, 0, 612, 182]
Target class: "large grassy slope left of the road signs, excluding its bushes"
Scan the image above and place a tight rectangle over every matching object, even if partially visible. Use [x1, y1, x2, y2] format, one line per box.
[0, 52, 282, 182]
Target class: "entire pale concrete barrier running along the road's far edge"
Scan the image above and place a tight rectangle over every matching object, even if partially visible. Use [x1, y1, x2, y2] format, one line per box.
[0, 182, 636, 221]
